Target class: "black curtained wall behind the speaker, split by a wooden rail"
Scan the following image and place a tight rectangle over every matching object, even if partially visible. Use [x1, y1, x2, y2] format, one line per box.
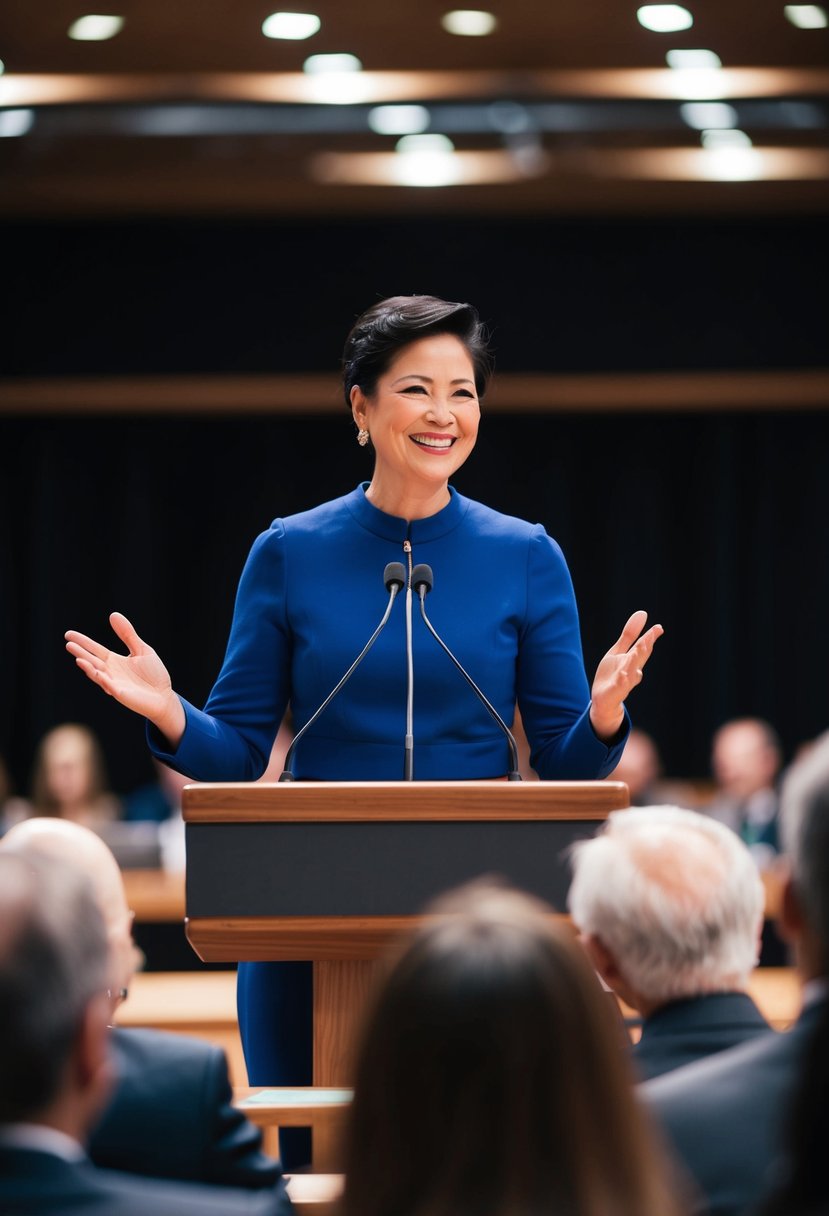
[0, 216, 829, 792]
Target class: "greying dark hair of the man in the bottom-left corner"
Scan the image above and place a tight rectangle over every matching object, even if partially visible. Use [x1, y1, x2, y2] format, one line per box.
[0, 850, 108, 1124]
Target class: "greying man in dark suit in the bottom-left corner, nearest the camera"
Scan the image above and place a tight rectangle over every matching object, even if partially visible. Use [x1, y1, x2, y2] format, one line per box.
[0, 849, 291, 1216]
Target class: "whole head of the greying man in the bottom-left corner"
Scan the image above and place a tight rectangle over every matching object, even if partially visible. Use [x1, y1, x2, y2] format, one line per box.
[0, 849, 109, 1123]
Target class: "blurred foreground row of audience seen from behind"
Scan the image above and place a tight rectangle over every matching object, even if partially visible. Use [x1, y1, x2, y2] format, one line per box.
[0, 733, 829, 1216]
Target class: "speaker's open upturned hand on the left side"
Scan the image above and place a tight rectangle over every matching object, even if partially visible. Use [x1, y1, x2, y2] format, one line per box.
[64, 612, 185, 751]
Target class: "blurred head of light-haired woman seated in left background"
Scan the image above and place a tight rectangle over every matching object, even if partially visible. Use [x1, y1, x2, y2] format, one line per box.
[32, 722, 114, 827]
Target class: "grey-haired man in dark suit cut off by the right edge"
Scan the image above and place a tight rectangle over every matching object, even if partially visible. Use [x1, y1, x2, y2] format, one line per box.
[642, 732, 829, 1216]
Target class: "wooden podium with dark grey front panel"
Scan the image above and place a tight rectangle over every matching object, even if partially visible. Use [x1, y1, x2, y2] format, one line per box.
[182, 781, 619, 1086]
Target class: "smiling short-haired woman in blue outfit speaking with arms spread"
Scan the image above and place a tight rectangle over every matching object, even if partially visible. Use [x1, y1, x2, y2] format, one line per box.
[66, 295, 662, 1138]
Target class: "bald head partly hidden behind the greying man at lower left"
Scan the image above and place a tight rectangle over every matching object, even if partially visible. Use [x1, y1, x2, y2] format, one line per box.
[0, 818, 140, 1000]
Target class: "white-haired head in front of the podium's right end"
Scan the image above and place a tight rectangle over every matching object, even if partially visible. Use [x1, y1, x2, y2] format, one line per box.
[568, 806, 763, 1003]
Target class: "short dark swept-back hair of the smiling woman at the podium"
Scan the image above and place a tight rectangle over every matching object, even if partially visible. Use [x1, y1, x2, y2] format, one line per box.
[343, 295, 492, 410]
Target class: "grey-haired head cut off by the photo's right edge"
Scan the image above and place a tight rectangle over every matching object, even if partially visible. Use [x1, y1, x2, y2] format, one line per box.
[780, 732, 829, 979]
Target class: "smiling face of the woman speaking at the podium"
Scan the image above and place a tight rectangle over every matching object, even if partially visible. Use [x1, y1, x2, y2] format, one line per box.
[351, 333, 480, 492]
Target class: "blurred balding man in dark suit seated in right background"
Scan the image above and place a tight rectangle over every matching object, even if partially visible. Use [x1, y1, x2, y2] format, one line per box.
[701, 717, 783, 869]
